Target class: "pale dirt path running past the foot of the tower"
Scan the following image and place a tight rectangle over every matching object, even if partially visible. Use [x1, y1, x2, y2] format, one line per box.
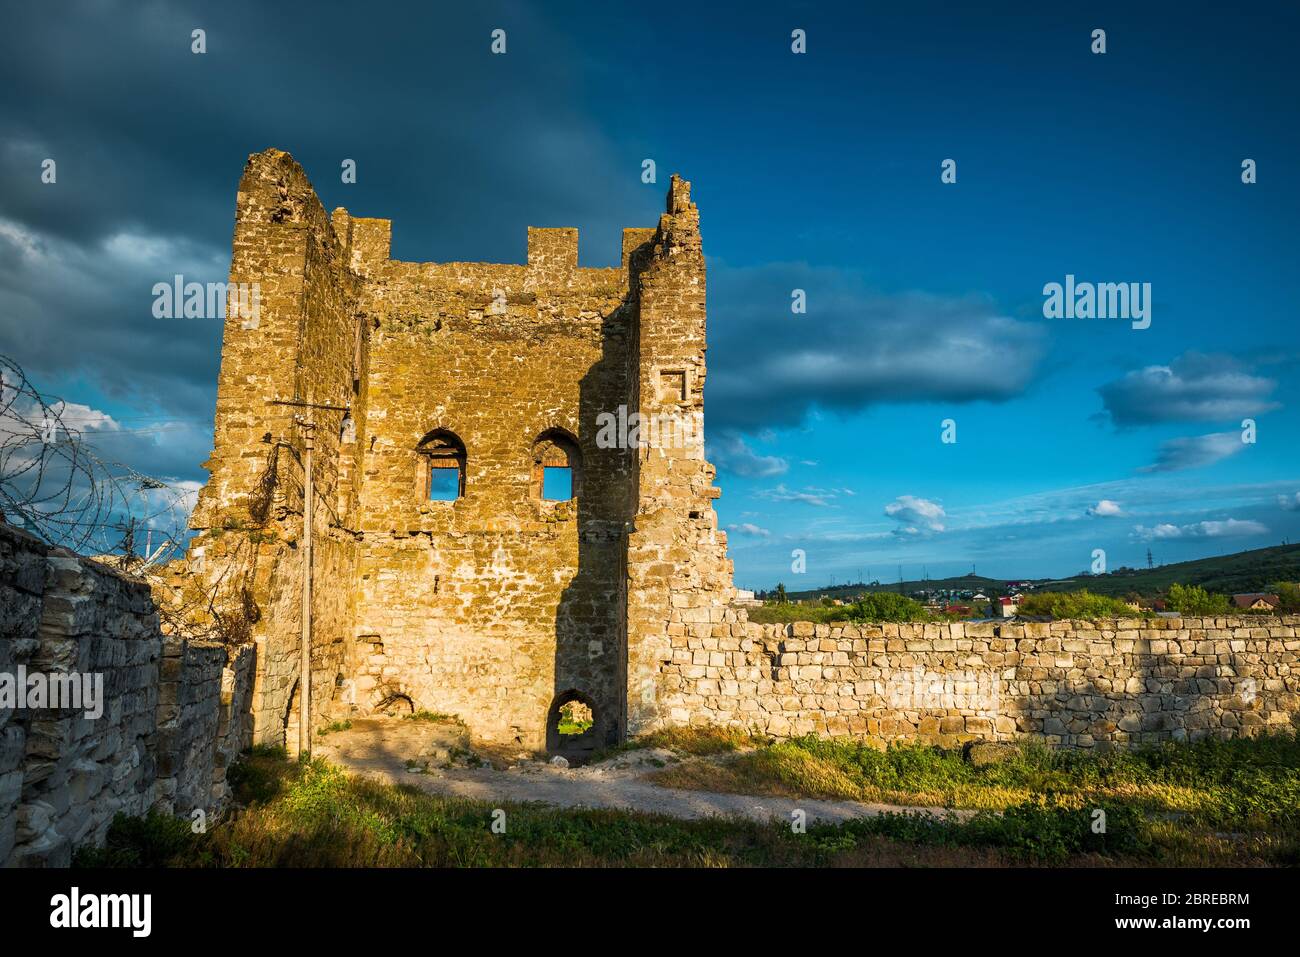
[316, 719, 969, 823]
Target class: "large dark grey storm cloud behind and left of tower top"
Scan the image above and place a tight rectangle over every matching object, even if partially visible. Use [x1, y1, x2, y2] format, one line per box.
[0, 3, 662, 475]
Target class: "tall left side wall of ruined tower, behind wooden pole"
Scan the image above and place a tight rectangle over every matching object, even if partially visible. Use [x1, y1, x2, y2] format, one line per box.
[189, 150, 364, 748]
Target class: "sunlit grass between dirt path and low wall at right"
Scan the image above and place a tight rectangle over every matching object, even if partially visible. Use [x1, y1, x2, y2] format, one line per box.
[651, 733, 1300, 863]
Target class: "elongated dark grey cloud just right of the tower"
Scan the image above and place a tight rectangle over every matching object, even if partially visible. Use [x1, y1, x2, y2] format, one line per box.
[709, 263, 1044, 432]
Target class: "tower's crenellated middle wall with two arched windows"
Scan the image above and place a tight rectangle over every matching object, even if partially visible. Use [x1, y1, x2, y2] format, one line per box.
[356, 229, 629, 746]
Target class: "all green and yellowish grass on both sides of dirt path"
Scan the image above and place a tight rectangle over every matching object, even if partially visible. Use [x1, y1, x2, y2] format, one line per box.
[77, 728, 1300, 867]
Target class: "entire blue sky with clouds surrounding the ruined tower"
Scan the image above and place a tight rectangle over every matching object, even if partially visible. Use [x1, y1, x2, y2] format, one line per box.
[0, 3, 1300, 586]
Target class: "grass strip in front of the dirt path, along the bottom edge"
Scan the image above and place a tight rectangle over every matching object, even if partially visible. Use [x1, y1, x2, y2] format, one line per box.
[75, 750, 1170, 867]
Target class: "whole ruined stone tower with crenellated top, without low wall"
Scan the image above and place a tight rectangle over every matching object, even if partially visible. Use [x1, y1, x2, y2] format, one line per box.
[190, 150, 737, 748]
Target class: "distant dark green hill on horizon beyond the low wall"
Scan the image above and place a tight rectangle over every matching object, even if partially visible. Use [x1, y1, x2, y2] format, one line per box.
[769, 545, 1300, 599]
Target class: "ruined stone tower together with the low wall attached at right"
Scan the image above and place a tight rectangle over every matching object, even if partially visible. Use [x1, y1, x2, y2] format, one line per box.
[165, 150, 1300, 749]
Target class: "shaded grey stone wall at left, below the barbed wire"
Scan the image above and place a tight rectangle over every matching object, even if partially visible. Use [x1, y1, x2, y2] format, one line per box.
[0, 524, 252, 866]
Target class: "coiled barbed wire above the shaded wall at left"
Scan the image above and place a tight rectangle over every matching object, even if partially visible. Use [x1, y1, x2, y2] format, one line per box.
[0, 355, 195, 571]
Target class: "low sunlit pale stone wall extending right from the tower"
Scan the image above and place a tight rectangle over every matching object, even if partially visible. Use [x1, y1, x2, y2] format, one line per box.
[662, 616, 1300, 748]
